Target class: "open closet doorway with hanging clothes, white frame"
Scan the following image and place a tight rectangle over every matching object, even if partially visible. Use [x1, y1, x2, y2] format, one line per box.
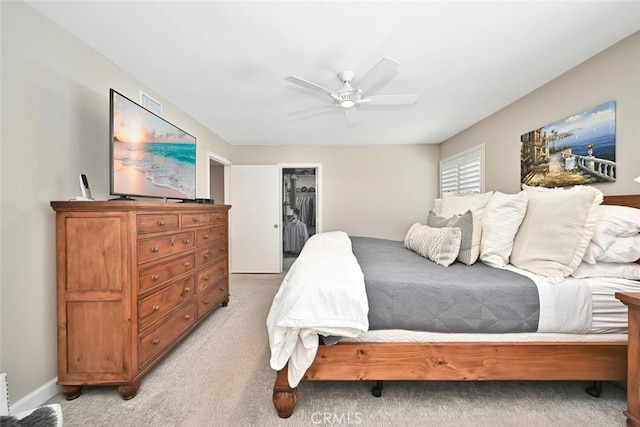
[280, 163, 322, 271]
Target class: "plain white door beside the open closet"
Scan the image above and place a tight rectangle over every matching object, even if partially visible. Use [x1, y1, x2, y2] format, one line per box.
[229, 165, 282, 273]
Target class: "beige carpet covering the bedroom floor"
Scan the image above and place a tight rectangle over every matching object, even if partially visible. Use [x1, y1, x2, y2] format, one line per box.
[50, 274, 626, 427]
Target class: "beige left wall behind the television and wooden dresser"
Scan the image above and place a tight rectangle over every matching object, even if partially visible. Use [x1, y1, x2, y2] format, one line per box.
[0, 1, 230, 403]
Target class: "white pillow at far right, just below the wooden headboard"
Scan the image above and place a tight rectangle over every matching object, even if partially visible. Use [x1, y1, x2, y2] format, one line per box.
[591, 205, 640, 248]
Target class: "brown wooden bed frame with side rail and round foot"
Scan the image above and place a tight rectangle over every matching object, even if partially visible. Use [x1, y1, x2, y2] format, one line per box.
[273, 195, 640, 418]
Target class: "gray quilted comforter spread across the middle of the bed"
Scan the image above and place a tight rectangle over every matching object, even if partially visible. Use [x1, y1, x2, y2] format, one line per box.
[351, 237, 540, 333]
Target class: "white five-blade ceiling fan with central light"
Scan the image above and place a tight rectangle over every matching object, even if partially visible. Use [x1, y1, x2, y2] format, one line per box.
[284, 57, 418, 124]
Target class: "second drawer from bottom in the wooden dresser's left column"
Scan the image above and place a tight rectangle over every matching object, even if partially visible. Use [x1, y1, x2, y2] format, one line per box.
[138, 276, 194, 330]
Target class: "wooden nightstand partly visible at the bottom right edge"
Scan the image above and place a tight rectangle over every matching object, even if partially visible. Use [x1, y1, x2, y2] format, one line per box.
[616, 292, 640, 427]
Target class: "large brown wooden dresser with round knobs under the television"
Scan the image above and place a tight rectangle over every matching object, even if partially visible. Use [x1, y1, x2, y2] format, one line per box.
[51, 201, 230, 400]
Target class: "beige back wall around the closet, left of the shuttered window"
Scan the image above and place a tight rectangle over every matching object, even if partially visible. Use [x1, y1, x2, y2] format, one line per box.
[233, 145, 440, 240]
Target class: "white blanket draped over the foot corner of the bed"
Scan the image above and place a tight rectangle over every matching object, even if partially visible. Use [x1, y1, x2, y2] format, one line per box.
[267, 231, 369, 387]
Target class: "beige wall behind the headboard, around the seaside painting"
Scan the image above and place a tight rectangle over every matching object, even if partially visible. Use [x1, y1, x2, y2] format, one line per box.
[441, 32, 640, 195]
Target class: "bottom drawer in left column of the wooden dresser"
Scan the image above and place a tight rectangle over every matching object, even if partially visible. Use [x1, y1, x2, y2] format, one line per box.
[138, 301, 196, 368]
